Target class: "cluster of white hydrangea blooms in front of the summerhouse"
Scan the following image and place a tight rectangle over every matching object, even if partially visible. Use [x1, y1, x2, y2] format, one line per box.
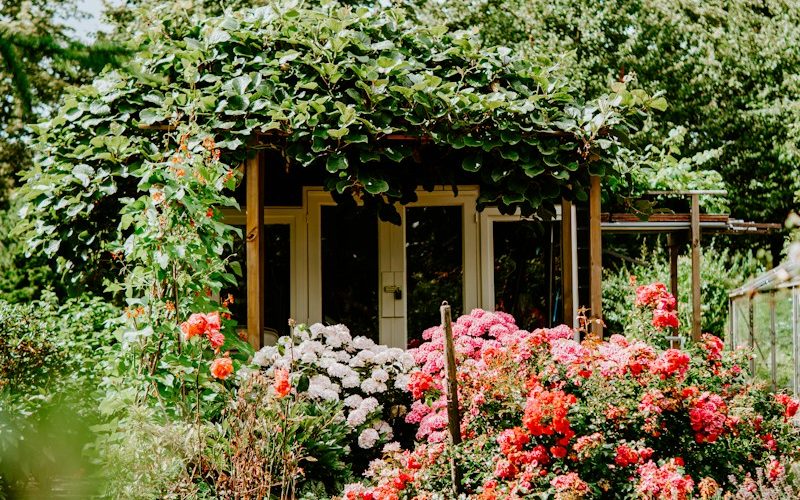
[253, 323, 415, 449]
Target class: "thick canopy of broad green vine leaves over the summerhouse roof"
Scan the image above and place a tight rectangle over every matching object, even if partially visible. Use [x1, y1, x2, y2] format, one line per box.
[18, 3, 666, 278]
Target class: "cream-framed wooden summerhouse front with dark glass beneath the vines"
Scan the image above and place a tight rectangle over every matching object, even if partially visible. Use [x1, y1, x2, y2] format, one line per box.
[225, 149, 601, 347]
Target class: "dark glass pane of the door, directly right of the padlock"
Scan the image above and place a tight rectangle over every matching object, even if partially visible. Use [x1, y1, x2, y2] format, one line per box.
[406, 206, 464, 347]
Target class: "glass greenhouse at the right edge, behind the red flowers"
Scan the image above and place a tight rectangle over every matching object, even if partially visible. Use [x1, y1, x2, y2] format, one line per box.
[729, 262, 800, 393]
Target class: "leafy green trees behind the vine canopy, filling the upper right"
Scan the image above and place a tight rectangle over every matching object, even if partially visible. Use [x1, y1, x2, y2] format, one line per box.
[408, 0, 800, 258]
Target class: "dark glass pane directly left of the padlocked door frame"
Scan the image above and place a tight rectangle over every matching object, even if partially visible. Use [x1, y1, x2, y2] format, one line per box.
[321, 206, 378, 341]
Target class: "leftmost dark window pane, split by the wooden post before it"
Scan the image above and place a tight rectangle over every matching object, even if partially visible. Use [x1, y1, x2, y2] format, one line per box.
[220, 224, 292, 342]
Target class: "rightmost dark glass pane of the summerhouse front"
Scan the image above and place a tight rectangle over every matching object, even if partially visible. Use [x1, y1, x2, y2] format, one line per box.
[492, 221, 563, 330]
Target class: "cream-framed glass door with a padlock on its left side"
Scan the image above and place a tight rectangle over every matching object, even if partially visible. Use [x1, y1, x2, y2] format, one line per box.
[379, 188, 480, 347]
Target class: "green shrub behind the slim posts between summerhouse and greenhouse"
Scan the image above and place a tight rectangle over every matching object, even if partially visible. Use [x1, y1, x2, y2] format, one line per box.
[603, 244, 764, 338]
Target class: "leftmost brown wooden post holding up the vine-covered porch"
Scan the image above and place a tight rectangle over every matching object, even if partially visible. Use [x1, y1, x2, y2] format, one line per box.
[245, 152, 265, 349]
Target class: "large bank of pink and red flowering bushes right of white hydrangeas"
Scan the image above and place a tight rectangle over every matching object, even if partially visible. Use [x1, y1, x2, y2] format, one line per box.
[344, 294, 800, 499]
